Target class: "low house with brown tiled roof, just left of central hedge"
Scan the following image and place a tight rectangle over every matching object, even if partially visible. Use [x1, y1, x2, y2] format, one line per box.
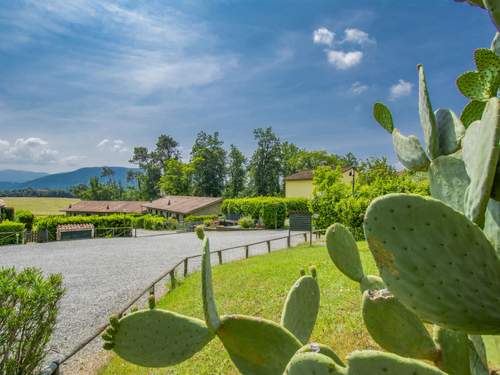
[144, 195, 222, 222]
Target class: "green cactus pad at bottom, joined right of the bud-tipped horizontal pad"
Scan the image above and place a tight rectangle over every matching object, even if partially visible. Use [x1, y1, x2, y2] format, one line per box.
[217, 315, 302, 375]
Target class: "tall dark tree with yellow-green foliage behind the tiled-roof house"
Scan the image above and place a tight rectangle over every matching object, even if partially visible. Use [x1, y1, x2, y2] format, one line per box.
[191, 131, 226, 197]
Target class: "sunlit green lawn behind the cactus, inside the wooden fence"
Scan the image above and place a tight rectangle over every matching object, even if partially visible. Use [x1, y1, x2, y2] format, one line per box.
[99, 242, 378, 375]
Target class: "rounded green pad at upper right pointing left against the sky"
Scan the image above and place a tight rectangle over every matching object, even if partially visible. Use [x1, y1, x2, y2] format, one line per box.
[457, 70, 498, 101]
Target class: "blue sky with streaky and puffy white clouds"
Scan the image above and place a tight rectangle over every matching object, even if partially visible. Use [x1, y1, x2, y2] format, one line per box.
[0, 0, 494, 172]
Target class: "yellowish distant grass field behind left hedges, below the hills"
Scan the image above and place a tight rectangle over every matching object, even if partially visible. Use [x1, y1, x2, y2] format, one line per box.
[2, 197, 79, 216]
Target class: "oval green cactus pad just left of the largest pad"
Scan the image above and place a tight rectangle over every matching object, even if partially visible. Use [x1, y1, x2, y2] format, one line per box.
[326, 223, 365, 283]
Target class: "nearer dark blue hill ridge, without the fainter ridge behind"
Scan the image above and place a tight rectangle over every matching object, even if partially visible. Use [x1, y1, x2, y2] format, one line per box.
[0, 167, 136, 190]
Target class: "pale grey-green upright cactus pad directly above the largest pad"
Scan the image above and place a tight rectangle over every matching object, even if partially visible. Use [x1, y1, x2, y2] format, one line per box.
[429, 152, 470, 212]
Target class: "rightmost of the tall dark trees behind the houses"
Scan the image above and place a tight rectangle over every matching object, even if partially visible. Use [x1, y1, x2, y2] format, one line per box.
[249, 127, 281, 195]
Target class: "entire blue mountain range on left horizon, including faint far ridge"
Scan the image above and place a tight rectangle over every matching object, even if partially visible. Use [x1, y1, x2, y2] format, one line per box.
[0, 167, 137, 190]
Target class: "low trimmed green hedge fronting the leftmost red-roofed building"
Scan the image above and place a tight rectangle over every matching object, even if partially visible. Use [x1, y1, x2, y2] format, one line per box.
[34, 214, 134, 238]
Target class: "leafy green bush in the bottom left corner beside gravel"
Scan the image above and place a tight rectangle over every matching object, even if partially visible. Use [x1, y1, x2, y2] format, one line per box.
[0, 268, 64, 375]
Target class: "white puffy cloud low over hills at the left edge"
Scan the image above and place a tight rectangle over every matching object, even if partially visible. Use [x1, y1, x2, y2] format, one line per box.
[0, 137, 59, 164]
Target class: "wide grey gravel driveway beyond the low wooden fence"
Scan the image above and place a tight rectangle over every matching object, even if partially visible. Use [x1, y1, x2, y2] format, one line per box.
[0, 231, 303, 374]
